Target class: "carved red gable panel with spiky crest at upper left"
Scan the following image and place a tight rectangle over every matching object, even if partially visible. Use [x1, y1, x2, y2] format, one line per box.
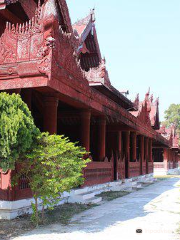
[0, 3, 44, 65]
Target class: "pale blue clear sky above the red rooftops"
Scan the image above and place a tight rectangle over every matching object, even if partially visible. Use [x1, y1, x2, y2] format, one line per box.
[67, 0, 180, 120]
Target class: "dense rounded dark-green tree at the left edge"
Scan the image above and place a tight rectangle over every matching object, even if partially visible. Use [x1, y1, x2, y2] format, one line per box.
[0, 93, 39, 171]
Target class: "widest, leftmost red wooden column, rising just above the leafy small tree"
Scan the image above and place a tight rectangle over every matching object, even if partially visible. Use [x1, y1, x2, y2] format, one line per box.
[44, 97, 58, 134]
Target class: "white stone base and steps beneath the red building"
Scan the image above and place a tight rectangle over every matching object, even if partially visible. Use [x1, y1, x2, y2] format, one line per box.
[0, 174, 155, 220]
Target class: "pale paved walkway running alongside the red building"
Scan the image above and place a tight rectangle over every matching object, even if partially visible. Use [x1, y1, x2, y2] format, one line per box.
[15, 178, 180, 240]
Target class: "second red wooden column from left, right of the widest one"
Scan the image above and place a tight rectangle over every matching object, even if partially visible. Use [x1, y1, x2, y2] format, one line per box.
[81, 111, 91, 152]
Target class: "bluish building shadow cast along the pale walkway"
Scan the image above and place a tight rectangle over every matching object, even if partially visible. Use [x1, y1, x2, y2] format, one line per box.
[13, 178, 179, 240]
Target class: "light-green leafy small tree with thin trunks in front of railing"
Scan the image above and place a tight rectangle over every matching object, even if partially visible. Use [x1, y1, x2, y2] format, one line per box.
[16, 133, 89, 225]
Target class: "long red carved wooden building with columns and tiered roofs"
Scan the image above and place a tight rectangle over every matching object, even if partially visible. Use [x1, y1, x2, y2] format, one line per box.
[0, 0, 179, 218]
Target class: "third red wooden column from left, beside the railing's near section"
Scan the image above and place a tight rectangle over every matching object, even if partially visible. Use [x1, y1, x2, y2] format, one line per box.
[98, 117, 106, 161]
